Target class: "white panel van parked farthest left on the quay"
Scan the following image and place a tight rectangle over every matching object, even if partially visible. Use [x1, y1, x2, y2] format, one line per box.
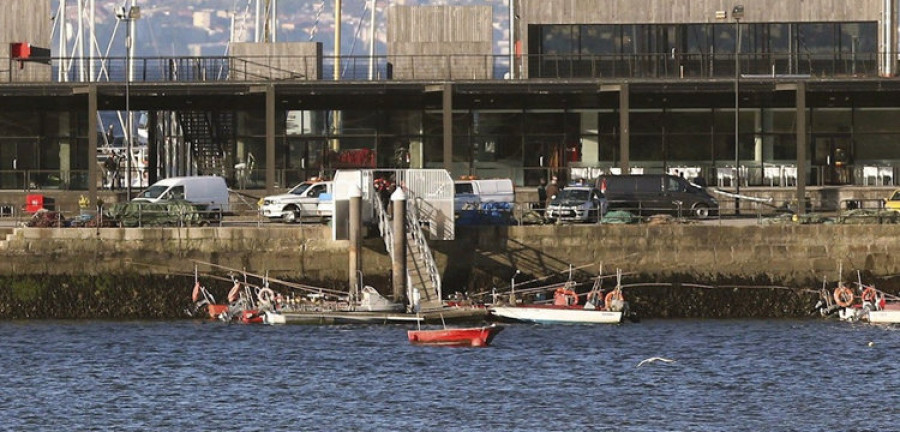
[132, 176, 231, 213]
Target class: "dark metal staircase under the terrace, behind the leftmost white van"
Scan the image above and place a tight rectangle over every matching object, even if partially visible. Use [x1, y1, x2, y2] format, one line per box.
[178, 111, 234, 177]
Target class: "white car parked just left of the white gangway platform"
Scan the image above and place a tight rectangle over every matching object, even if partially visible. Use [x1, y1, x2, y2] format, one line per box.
[259, 181, 334, 223]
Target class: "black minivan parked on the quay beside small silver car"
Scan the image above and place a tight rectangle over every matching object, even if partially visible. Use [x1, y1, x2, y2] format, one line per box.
[597, 174, 719, 219]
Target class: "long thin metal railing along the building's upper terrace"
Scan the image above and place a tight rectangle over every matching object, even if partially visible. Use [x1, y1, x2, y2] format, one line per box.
[0, 52, 884, 82]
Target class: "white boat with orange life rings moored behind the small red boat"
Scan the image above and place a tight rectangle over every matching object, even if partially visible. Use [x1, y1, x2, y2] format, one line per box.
[490, 272, 628, 324]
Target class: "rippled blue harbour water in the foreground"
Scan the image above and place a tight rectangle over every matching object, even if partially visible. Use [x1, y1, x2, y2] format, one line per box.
[0, 320, 900, 431]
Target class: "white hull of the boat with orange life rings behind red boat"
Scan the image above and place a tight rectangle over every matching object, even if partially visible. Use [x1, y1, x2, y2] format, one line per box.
[491, 306, 623, 324]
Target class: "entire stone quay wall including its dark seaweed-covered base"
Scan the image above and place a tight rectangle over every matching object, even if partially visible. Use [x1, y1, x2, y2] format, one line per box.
[0, 225, 900, 319]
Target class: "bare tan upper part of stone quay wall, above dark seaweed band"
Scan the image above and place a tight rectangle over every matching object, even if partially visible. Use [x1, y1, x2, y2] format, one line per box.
[0, 224, 900, 292]
